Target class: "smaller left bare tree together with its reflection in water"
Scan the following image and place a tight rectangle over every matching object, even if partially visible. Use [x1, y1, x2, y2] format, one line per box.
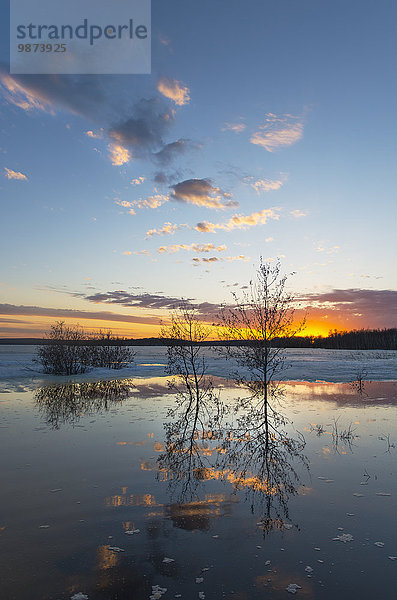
[158, 304, 222, 497]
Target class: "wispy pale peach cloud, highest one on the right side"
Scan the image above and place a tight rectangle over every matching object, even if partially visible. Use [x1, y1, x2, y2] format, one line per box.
[250, 113, 303, 152]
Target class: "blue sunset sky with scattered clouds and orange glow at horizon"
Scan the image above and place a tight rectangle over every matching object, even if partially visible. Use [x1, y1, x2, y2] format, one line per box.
[0, 0, 397, 338]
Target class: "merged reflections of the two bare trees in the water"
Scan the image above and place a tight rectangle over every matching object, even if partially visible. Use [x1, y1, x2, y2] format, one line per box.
[158, 380, 308, 533]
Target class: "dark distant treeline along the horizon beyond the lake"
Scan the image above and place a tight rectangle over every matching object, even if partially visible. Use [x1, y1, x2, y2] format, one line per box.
[0, 328, 397, 350]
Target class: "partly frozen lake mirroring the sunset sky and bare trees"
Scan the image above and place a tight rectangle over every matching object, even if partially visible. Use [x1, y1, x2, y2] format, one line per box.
[0, 346, 397, 600]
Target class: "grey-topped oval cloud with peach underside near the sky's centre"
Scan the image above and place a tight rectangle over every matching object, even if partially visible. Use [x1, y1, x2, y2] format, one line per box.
[170, 179, 238, 209]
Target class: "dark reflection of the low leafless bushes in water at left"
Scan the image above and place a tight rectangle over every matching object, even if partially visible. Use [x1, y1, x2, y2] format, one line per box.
[35, 379, 133, 429]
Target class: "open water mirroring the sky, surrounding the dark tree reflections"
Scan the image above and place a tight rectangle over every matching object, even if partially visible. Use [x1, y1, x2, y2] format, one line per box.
[0, 377, 397, 600]
